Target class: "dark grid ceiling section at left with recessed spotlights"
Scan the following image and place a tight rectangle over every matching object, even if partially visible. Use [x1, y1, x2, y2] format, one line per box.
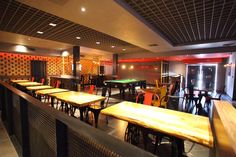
[0, 0, 148, 53]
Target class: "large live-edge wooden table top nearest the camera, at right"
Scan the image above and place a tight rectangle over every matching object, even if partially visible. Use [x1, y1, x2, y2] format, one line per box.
[101, 101, 213, 147]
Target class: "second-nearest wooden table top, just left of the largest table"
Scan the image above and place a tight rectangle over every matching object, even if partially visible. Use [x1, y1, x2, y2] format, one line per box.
[49, 91, 105, 107]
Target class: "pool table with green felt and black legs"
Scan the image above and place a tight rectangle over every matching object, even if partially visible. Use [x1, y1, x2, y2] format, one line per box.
[104, 79, 146, 98]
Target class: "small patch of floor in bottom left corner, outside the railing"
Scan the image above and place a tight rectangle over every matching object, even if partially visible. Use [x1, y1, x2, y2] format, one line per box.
[0, 120, 18, 157]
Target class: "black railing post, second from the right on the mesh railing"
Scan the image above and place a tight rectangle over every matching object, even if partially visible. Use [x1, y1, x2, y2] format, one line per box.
[20, 97, 30, 157]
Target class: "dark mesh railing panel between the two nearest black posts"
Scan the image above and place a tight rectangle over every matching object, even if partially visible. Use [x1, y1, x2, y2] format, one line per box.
[28, 104, 56, 157]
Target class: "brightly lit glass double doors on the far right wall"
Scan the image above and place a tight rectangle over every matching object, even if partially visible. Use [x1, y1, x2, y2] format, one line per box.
[186, 64, 217, 91]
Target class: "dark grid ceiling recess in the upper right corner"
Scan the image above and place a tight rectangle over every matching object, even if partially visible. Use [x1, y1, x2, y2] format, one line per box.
[120, 0, 236, 46]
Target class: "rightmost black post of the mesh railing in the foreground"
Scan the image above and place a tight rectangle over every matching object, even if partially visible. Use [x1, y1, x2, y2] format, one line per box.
[56, 119, 68, 157]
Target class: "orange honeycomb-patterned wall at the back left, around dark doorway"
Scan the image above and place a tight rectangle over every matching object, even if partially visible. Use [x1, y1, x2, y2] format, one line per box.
[0, 52, 99, 77]
